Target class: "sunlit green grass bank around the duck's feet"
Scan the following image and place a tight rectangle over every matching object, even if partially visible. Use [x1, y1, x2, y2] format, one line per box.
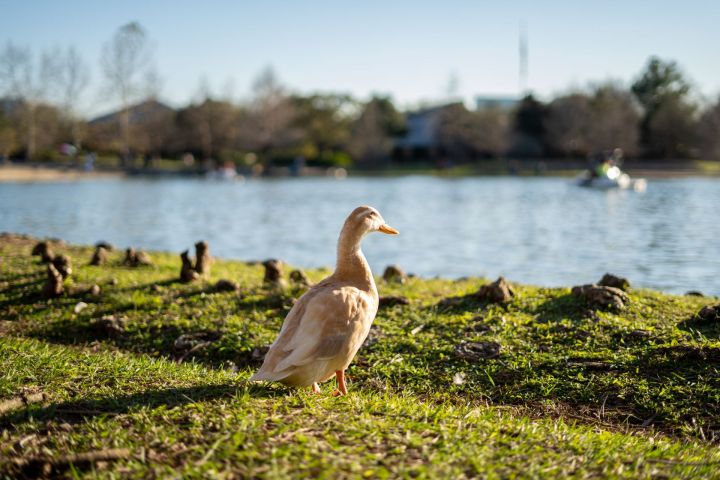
[0, 236, 720, 478]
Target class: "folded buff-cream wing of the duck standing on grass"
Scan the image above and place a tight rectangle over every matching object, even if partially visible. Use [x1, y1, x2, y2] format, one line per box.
[250, 285, 372, 380]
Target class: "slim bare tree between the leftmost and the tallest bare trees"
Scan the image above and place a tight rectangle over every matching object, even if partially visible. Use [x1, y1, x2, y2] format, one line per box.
[58, 47, 90, 150]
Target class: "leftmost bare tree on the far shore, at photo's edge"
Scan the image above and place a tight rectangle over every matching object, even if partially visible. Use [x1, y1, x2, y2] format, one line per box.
[0, 43, 60, 159]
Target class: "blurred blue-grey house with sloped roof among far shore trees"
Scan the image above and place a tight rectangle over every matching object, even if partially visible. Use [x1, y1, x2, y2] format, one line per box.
[393, 103, 458, 161]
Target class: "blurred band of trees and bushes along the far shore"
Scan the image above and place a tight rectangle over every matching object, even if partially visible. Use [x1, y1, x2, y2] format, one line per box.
[0, 23, 720, 175]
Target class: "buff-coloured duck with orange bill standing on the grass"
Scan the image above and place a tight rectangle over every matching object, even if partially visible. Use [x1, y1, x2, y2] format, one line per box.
[250, 205, 399, 396]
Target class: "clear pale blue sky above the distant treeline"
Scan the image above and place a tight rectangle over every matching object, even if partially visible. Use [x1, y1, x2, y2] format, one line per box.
[0, 0, 720, 114]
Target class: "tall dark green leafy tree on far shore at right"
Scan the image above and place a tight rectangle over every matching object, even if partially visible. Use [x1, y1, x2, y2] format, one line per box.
[632, 57, 694, 157]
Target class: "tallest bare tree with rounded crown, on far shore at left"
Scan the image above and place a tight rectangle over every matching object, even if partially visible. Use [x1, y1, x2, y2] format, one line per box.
[101, 22, 150, 163]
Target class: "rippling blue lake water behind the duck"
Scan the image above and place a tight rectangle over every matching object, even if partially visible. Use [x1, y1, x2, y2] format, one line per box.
[0, 176, 720, 295]
